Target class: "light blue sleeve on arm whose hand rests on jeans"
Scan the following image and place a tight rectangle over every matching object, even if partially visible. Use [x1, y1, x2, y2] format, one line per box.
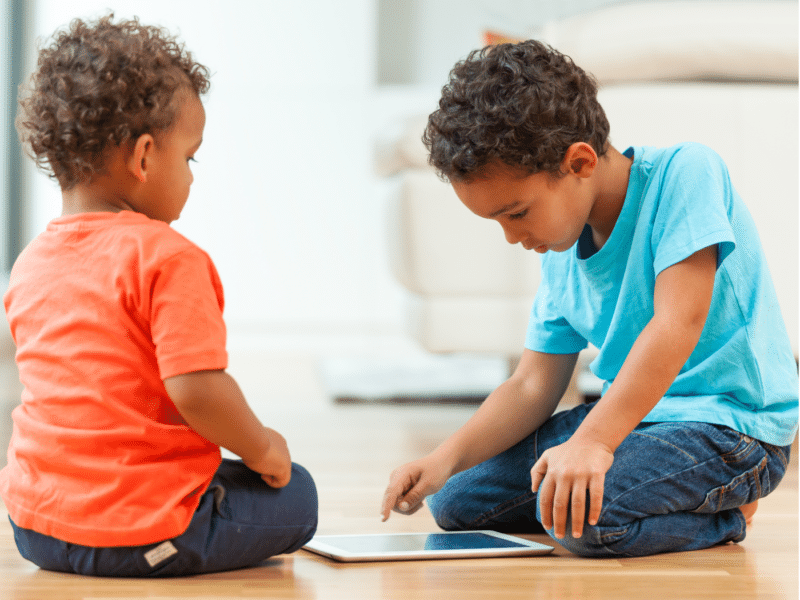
[651, 144, 735, 275]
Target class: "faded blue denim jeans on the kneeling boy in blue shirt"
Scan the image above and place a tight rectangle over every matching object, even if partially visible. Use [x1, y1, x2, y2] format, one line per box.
[428, 404, 790, 557]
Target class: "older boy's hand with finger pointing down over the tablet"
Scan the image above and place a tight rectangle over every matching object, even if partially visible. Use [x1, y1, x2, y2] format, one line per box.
[381, 457, 450, 521]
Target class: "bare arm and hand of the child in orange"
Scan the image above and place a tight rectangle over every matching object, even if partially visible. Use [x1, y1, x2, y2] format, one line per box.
[164, 371, 292, 488]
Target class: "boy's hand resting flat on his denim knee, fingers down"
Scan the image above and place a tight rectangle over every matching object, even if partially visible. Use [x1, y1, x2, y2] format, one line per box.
[531, 439, 614, 538]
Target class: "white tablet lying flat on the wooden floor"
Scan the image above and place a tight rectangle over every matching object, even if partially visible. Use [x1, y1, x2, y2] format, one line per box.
[303, 531, 553, 562]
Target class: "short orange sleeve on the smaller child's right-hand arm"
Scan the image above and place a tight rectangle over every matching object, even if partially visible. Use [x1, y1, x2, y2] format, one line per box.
[150, 248, 228, 379]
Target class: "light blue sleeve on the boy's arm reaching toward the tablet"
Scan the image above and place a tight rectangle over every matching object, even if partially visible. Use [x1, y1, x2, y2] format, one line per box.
[525, 278, 588, 354]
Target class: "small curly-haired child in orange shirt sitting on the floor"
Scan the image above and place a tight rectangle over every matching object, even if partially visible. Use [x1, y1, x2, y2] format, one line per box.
[0, 15, 317, 577]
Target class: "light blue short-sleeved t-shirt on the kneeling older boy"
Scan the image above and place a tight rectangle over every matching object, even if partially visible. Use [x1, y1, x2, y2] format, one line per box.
[525, 144, 798, 446]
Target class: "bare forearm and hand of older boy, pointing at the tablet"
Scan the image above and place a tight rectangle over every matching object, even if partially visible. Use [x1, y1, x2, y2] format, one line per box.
[381, 350, 577, 521]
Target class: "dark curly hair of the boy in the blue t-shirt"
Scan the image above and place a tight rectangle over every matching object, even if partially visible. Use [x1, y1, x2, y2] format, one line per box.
[422, 40, 609, 182]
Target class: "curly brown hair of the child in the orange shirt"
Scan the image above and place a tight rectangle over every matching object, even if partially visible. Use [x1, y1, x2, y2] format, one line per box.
[16, 14, 209, 190]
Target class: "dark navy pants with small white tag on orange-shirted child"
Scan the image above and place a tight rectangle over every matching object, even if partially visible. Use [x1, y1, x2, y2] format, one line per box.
[9, 459, 317, 577]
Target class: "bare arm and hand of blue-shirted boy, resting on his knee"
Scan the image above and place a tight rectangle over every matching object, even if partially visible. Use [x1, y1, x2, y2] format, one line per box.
[531, 246, 717, 538]
